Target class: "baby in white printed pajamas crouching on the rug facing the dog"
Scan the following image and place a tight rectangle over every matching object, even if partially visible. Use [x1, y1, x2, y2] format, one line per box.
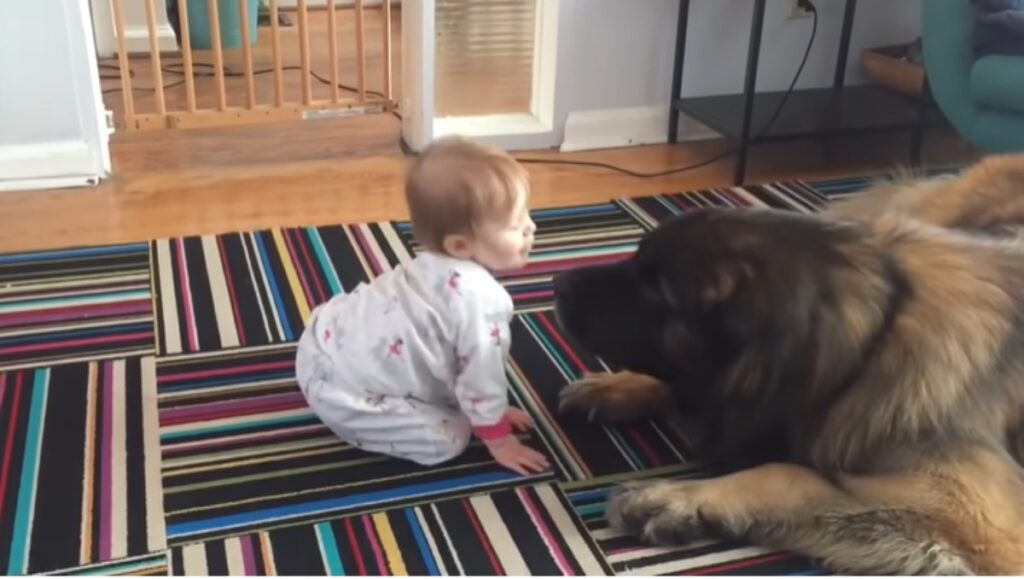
[296, 138, 548, 474]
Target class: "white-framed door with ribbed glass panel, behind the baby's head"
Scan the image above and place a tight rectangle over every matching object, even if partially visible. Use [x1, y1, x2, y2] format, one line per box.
[400, 0, 560, 151]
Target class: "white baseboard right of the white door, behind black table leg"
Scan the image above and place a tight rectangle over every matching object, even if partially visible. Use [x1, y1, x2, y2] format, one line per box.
[560, 106, 721, 153]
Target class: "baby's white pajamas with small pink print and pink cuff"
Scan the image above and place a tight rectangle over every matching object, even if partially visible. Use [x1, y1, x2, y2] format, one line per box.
[296, 252, 520, 464]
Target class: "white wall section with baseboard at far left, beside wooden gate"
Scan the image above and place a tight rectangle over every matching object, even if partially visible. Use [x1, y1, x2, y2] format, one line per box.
[0, 0, 110, 190]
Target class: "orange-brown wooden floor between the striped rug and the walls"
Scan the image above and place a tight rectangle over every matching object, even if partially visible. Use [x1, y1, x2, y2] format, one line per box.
[0, 115, 973, 252]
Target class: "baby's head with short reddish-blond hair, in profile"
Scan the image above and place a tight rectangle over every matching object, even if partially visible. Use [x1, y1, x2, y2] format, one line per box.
[406, 137, 537, 271]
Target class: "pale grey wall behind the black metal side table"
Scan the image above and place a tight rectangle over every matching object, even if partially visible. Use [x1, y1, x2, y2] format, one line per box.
[548, 0, 922, 151]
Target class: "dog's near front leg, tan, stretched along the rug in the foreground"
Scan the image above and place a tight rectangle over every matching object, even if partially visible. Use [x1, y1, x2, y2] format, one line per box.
[607, 446, 1024, 575]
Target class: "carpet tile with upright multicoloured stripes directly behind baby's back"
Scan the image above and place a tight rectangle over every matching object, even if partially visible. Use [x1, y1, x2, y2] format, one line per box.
[152, 223, 409, 355]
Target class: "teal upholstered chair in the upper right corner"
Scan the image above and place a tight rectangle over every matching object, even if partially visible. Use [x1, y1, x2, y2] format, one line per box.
[921, 0, 1024, 153]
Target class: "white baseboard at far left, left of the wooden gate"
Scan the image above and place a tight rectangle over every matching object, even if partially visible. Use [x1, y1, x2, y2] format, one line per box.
[0, 141, 105, 191]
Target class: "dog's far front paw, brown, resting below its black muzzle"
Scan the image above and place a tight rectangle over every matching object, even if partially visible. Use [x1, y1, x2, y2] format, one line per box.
[558, 372, 675, 422]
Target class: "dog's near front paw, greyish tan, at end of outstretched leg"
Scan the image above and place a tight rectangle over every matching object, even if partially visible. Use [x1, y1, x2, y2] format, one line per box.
[605, 481, 720, 545]
